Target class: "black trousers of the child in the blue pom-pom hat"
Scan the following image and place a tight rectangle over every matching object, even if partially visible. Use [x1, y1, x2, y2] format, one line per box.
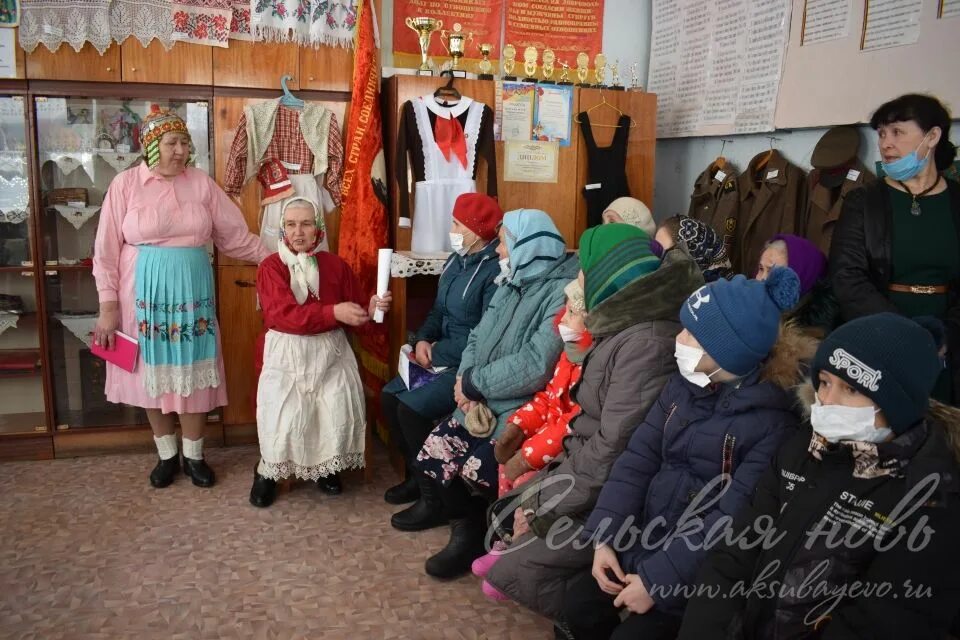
[563, 571, 682, 640]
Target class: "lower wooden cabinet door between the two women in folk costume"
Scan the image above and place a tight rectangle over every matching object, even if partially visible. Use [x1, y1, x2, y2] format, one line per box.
[217, 266, 263, 426]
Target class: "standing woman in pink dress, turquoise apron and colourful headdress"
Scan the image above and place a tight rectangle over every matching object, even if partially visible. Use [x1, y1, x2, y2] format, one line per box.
[93, 107, 269, 488]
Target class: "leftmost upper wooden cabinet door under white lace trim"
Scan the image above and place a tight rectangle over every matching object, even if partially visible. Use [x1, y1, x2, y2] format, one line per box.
[26, 38, 122, 82]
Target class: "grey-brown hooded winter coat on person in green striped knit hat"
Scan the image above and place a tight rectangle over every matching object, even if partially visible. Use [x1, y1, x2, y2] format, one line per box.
[486, 249, 703, 619]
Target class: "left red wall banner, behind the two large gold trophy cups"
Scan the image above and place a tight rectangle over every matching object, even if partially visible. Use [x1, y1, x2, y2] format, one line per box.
[393, 0, 503, 72]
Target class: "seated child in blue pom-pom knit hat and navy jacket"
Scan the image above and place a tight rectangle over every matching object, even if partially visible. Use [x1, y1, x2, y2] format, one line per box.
[563, 267, 816, 640]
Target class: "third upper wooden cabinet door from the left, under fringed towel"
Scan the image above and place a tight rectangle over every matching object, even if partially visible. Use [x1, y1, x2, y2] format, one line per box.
[213, 40, 301, 89]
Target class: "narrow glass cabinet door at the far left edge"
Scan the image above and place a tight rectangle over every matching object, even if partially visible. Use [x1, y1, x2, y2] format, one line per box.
[0, 96, 48, 435]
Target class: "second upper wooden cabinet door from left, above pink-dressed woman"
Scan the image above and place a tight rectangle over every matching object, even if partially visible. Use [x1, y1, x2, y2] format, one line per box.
[120, 38, 213, 85]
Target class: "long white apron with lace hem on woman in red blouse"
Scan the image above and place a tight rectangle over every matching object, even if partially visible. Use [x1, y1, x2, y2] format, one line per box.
[257, 329, 366, 480]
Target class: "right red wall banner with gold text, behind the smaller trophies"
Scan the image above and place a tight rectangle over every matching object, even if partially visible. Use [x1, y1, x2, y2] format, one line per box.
[503, 0, 603, 62]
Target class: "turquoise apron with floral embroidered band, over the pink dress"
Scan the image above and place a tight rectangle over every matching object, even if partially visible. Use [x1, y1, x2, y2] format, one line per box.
[135, 245, 220, 398]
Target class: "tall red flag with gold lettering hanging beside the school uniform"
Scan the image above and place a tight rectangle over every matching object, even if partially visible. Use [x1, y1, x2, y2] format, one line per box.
[339, 0, 390, 384]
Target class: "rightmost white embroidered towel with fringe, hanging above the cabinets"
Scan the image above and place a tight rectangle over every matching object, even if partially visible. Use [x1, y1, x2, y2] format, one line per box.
[250, 0, 357, 47]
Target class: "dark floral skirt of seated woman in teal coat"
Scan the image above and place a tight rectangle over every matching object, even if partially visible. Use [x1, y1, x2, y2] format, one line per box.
[416, 417, 499, 489]
